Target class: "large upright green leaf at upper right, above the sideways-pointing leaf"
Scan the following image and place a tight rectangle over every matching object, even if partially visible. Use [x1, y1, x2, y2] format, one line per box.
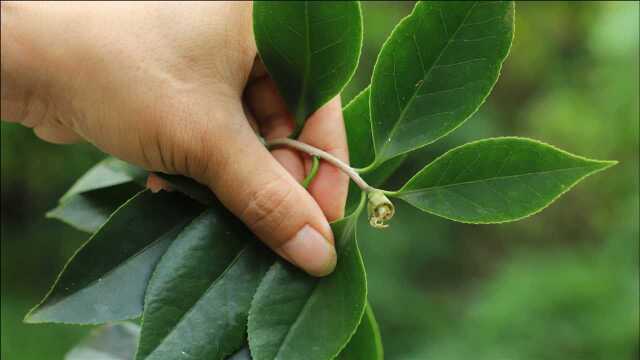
[371, 1, 514, 164]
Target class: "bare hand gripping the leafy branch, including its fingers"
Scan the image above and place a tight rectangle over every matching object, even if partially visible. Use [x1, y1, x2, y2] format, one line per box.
[1, 2, 349, 276]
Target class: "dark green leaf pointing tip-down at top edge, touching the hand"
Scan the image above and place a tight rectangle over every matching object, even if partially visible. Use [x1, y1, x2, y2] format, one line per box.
[253, 1, 362, 130]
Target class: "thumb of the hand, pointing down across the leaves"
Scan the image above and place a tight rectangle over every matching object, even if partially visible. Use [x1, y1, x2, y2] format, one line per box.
[202, 102, 336, 276]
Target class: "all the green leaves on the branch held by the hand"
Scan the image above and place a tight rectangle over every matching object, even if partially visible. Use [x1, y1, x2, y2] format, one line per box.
[26, 1, 613, 360]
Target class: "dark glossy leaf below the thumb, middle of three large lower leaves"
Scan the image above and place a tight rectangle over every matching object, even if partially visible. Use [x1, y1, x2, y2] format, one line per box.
[136, 205, 274, 360]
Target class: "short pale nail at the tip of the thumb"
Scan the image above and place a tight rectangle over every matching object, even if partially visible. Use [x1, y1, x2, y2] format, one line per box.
[280, 225, 337, 276]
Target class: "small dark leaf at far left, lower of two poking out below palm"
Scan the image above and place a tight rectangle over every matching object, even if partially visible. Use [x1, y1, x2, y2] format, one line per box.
[47, 182, 141, 233]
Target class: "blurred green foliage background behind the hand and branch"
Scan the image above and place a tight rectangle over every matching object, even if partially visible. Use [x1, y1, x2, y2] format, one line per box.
[0, 2, 640, 360]
